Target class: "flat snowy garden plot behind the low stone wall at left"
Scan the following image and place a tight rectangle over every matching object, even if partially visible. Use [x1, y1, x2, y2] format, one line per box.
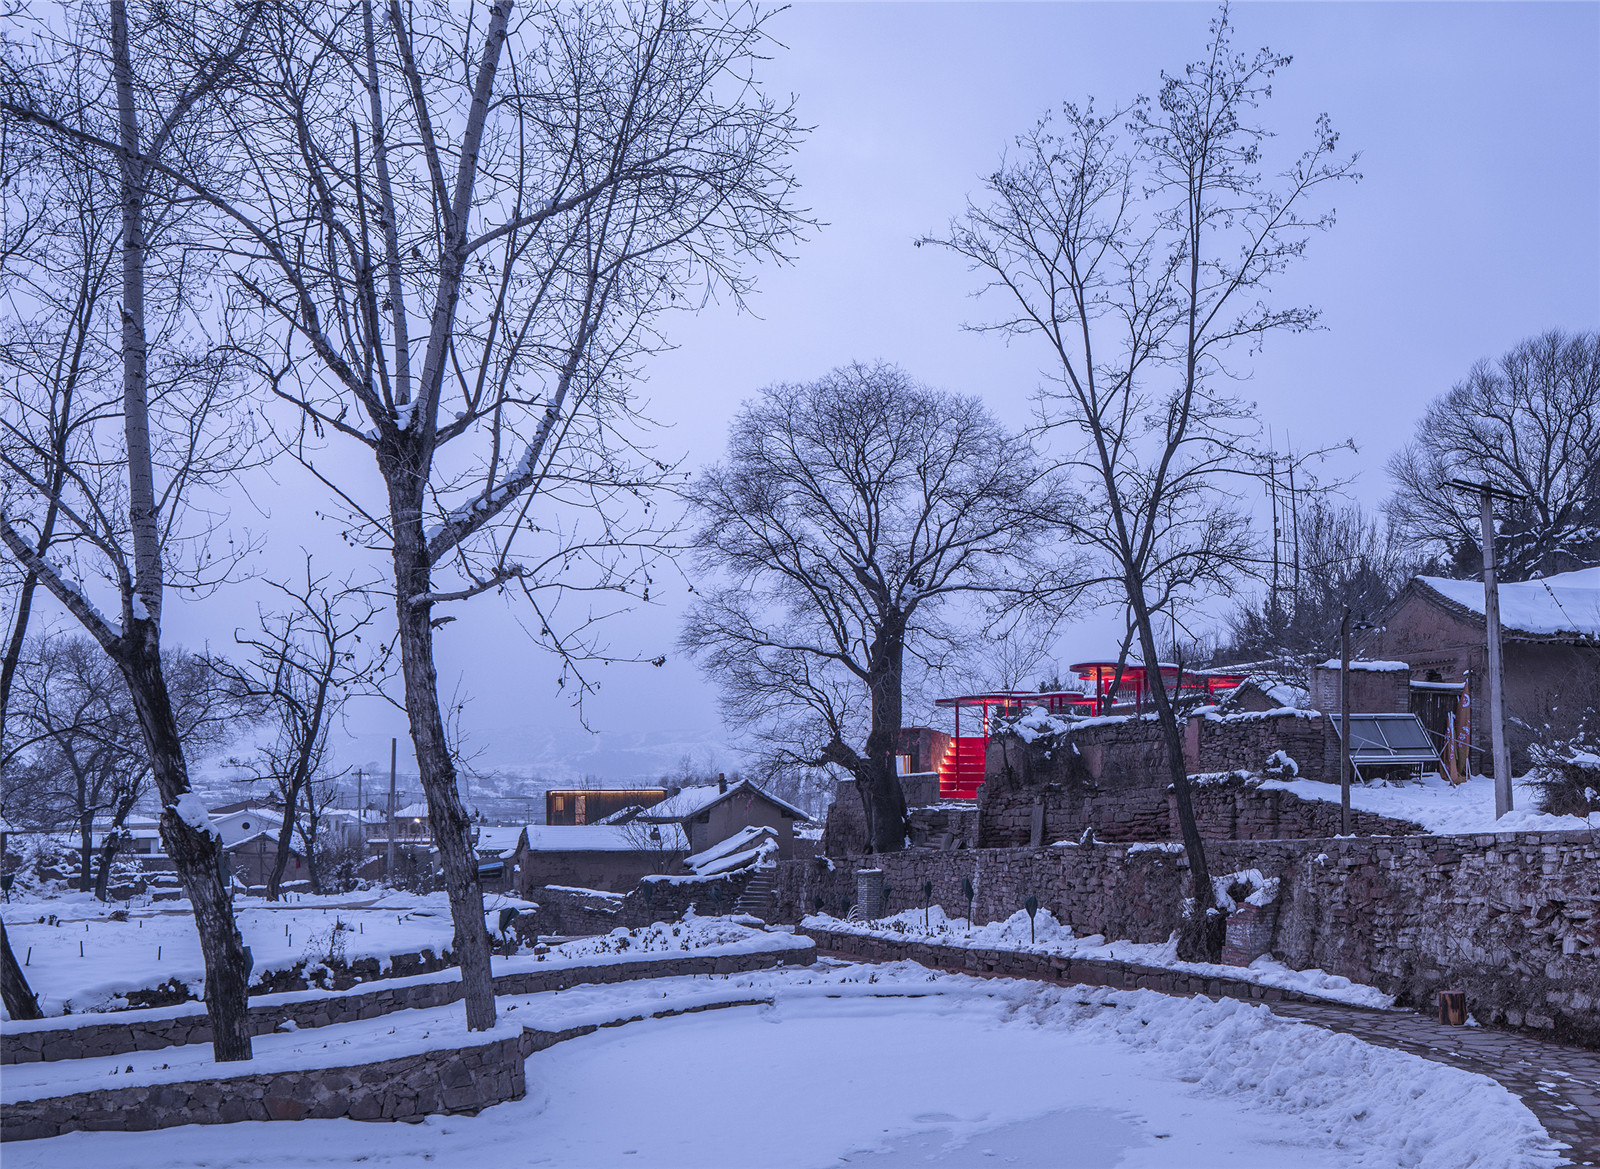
[3, 891, 499, 1015]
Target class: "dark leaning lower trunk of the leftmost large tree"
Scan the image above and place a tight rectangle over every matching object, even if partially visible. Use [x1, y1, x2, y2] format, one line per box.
[118, 620, 251, 1063]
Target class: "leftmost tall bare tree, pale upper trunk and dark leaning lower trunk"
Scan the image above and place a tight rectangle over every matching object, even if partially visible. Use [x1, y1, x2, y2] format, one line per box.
[0, 0, 264, 1062]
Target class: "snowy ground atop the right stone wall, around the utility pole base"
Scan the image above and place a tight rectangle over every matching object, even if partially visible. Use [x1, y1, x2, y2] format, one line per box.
[1261, 774, 1600, 835]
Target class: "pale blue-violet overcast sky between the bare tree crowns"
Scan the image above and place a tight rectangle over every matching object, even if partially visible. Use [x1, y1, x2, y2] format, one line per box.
[152, 3, 1600, 780]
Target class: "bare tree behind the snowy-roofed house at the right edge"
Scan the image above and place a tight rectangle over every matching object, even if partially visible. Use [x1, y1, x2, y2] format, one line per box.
[1387, 329, 1600, 581]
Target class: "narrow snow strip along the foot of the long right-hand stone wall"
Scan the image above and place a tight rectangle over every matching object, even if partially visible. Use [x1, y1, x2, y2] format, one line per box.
[802, 905, 1394, 1007]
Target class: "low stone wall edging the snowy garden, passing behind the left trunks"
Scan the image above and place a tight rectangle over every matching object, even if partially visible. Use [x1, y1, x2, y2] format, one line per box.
[0, 950, 811, 1063]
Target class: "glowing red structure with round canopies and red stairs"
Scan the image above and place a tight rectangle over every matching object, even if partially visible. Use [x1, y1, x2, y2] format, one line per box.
[934, 662, 1248, 800]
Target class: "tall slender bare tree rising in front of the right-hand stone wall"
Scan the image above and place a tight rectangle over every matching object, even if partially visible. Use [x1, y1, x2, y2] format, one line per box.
[930, 6, 1354, 960]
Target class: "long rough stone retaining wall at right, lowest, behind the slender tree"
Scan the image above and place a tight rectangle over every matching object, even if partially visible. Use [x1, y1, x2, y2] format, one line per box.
[778, 833, 1600, 1046]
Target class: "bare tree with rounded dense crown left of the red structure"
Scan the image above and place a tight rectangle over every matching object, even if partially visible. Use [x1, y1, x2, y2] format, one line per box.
[682, 365, 1059, 852]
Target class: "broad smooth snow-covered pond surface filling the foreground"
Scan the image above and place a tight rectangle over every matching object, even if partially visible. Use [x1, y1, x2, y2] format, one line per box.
[5, 963, 1562, 1169]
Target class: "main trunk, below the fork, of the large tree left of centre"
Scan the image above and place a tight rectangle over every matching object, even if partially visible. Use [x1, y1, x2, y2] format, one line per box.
[384, 462, 494, 1031]
